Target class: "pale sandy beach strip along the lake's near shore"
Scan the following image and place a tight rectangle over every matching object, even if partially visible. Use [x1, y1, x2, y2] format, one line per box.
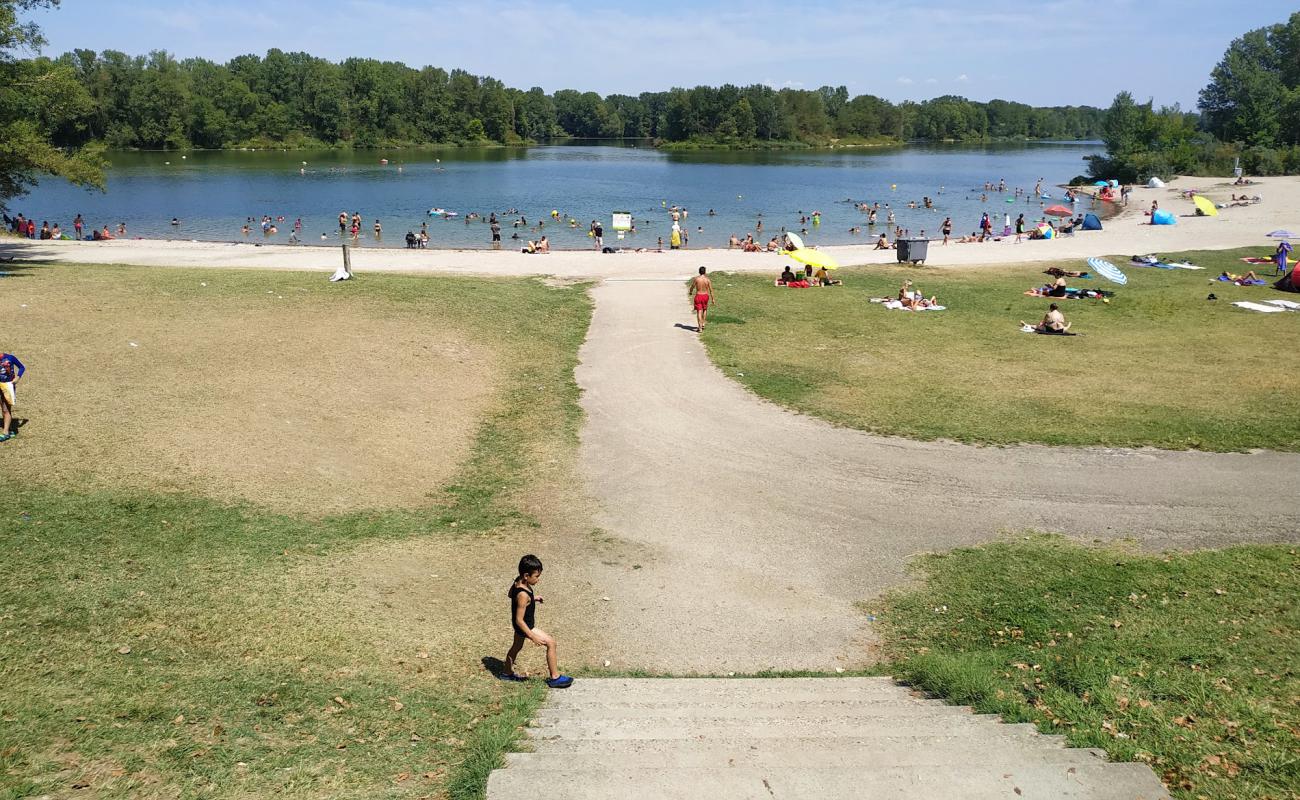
[0, 177, 1300, 278]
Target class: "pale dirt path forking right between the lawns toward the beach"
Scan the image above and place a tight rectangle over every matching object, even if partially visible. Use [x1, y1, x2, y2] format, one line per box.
[577, 281, 1300, 671]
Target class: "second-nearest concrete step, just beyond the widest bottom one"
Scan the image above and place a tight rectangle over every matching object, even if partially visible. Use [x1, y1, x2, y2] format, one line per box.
[506, 740, 1106, 771]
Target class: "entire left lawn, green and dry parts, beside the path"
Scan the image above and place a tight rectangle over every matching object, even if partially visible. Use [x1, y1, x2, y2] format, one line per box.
[0, 265, 590, 799]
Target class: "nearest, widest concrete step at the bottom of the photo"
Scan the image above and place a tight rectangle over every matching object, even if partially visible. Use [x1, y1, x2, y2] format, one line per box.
[488, 762, 1167, 800]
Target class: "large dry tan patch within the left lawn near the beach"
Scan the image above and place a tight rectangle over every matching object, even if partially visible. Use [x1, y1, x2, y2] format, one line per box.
[5, 269, 498, 513]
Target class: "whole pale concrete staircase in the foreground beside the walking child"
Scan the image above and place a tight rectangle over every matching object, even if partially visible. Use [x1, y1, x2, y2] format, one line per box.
[488, 678, 1169, 800]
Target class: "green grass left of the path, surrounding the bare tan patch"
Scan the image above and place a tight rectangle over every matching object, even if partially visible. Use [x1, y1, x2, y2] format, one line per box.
[0, 267, 590, 799]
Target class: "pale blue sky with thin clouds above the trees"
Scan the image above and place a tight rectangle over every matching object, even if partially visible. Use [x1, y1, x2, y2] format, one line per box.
[27, 0, 1296, 111]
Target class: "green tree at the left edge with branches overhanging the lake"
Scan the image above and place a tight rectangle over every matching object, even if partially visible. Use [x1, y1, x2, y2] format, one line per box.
[0, 0, 104, 208]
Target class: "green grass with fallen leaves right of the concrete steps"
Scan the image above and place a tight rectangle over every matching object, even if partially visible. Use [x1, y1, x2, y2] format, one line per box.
[880, 536, 1300, 800]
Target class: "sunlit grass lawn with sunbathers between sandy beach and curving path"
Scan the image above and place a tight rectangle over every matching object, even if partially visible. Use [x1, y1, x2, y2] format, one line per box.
[703, 245, 1300, 450]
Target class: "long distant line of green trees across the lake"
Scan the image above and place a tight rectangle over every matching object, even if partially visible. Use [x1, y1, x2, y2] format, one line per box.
[34, 49, 1105, 148]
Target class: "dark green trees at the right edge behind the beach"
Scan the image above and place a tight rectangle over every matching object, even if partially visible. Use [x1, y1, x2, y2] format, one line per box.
[1091, 12, 1300, 181]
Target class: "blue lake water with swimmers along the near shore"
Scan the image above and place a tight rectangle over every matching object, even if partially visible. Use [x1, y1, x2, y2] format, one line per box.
[10, 143, 1101, 248]
